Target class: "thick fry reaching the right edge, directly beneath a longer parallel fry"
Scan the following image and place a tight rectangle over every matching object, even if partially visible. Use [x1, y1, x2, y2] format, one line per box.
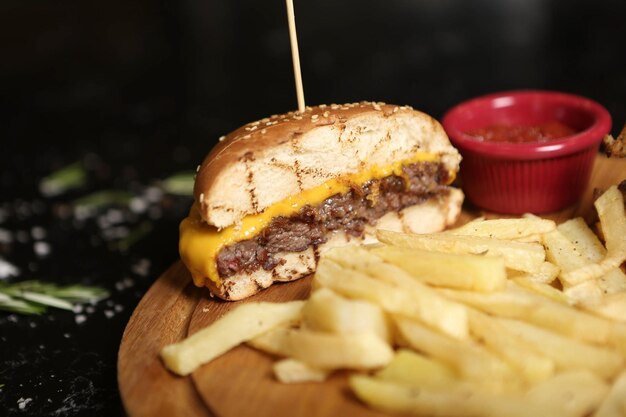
[495, 318, 624, 379]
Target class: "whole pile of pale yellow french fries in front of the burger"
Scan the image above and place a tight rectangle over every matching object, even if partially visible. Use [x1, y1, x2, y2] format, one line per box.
[161, 187, 626, 417]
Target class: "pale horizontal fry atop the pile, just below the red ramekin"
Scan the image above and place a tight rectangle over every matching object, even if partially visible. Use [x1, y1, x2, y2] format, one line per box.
[445, 217, 556, 242]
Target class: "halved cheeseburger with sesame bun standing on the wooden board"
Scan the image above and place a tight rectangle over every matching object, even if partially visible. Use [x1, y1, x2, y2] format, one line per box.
[179, 102, 463, 300]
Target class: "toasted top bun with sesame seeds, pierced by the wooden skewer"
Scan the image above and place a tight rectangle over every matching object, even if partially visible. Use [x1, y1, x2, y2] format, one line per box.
[194, 102, 460, 228]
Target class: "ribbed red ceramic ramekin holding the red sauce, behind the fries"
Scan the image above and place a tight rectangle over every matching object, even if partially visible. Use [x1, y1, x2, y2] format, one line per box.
[442, 90, 611, 214]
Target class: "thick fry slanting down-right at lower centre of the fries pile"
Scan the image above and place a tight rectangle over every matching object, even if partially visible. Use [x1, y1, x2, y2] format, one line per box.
[394, 316, 520, 392]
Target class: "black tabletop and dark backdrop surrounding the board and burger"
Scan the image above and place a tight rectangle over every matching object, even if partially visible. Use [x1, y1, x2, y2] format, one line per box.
[0, 0, 626, 416]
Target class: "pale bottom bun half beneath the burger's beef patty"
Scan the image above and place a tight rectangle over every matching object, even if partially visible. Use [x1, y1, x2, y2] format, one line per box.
[206, 188, 463, 301]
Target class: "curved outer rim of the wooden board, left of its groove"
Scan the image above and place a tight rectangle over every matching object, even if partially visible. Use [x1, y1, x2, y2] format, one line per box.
[117, 262, 213, 417]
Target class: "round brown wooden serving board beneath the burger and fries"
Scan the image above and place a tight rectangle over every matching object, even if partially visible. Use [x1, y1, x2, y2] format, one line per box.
[118, 156, 626, 417]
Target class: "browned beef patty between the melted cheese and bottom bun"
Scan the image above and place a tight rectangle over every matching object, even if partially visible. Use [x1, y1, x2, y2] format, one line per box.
[217, 162, 449, 278]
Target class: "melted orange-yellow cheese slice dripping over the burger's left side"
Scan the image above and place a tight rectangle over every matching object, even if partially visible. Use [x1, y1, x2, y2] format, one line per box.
[179, 152, 446, 287]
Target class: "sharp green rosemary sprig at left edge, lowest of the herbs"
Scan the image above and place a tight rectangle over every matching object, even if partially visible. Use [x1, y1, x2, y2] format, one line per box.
[0, 281, 109, 314]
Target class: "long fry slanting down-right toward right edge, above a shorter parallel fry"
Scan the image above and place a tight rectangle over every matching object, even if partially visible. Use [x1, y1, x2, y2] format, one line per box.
[439, 283, 612, 343]
